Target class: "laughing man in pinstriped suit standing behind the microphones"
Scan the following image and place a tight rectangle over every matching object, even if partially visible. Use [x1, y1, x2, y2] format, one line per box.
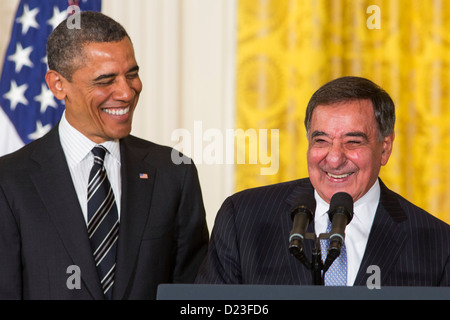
[196, 77, 450, 286]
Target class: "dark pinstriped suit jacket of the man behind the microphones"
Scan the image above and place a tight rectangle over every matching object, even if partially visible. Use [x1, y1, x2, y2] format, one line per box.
[196, 179, 450, 286]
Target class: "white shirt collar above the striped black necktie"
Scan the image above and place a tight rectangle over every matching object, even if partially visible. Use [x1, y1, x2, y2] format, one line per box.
[58, 111, 120, 168]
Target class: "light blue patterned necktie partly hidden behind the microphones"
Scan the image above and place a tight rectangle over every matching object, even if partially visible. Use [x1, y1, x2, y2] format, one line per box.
[320, 220, 347, 286]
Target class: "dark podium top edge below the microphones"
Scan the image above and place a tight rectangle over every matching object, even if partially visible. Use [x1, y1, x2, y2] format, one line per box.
[157, 284, 450, 301]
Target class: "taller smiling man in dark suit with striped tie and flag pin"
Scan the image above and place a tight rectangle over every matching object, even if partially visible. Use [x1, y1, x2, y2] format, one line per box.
[0, 12, 208, 299]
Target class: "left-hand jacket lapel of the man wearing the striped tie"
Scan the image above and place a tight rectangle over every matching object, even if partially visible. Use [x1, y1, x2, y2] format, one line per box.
[31, 126, 103, 299]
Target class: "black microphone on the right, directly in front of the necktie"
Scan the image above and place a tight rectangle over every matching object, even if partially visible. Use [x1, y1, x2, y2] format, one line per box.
[323, 192, 353, 272]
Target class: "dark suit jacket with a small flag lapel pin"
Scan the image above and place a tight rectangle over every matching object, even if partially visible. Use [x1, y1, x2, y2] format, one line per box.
[0, 127, 208, 299]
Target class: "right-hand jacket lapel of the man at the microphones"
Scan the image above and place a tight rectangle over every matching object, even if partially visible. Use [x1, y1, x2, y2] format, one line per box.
[355, 180, 407, 285]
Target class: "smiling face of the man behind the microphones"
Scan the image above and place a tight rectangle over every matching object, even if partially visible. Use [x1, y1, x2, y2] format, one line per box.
[307, 100, 394, 203]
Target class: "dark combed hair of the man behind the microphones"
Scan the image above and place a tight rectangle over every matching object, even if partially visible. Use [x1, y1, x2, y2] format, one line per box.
[305, 76, 395, 141]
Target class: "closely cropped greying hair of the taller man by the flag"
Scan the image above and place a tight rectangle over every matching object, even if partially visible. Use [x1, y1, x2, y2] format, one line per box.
[47, 11, 129, 81]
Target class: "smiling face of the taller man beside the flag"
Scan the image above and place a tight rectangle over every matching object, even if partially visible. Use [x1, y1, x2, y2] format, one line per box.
[57, 37, 142, 143]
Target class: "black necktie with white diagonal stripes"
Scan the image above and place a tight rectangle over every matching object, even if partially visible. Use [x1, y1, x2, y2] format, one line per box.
[87, 146, 119, 299]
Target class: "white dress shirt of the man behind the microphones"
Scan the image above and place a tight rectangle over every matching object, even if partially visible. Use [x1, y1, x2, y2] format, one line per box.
[314, 179, 380, 286]
